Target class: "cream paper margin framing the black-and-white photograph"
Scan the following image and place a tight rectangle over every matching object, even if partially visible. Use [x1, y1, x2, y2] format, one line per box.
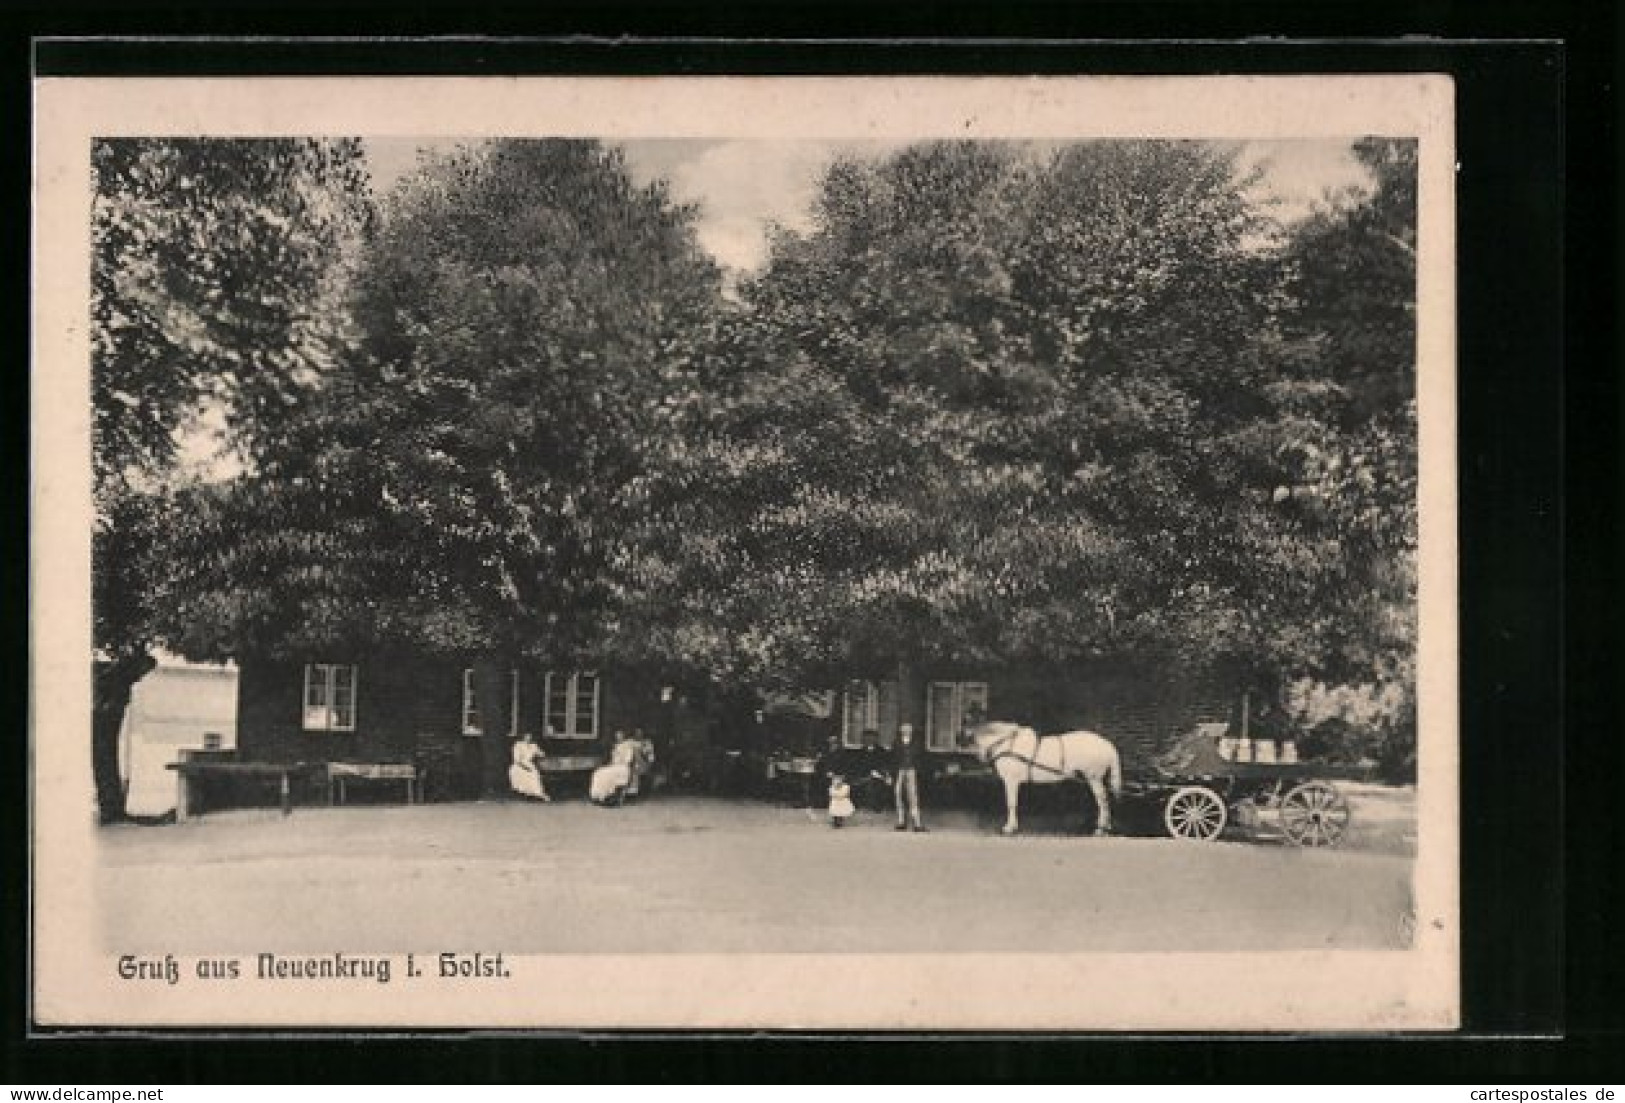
[29, 75, 1459, 1033]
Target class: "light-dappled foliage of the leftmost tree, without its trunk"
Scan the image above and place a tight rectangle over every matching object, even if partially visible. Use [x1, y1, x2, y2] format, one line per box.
[91, 138, 366, 513]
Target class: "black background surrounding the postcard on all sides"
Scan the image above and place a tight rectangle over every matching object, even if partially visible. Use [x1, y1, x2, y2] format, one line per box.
[0, 15, 1625, 1084]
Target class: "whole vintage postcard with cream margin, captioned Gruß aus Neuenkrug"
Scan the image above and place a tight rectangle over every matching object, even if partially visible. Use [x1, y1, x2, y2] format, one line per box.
[29, 75, 1459, 1033]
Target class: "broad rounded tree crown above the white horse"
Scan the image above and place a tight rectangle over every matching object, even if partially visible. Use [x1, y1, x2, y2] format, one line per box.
[627, 141, 1404, 724]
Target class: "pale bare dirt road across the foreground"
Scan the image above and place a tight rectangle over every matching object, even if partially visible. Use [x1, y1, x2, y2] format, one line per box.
[98, 798, 1411, 954]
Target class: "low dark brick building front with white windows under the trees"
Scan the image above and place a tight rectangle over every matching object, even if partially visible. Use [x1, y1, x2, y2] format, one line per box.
[237, 653, 1238, 799]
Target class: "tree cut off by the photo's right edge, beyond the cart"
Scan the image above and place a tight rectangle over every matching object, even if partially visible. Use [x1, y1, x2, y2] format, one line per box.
[1287, 138, 1417, 775]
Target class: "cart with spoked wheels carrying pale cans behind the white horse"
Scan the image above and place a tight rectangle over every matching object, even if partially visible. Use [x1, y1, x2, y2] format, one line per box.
[1123, 725, 1349, 846]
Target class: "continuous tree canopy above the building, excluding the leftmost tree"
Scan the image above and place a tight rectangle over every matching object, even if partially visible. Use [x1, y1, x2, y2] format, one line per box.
[130, 134, 1415, 776]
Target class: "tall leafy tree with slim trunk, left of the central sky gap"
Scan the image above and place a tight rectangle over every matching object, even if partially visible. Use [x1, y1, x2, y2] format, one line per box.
[169, 140, 718, 783]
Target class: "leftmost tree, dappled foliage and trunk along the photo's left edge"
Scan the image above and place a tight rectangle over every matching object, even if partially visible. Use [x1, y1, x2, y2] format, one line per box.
[91, 138, 366, 820]
